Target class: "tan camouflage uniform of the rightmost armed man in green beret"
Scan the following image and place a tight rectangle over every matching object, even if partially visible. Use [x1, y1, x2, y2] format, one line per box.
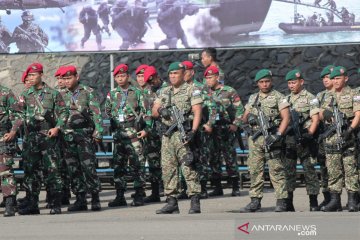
[322, 86, 360, 193]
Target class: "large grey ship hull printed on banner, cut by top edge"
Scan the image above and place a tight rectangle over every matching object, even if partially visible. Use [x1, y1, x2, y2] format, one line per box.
[210, 0, 272, 41]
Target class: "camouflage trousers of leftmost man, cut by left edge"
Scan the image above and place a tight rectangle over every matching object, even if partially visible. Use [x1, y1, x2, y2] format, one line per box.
[0, 132, 16, 197]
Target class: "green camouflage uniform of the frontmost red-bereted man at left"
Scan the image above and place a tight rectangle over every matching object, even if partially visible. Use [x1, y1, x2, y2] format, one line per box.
[19, 83, 69, 212]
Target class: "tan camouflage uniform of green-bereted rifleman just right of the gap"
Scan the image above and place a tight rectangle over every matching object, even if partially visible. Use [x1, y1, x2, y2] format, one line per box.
[245, 90, 289, 199]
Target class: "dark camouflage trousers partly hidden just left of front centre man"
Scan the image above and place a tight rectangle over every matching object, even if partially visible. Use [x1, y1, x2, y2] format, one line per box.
[144, 131, 161, 182]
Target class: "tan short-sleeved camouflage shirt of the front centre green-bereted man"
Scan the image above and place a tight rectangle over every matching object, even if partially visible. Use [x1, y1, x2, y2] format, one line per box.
[155, 83, 203, 126]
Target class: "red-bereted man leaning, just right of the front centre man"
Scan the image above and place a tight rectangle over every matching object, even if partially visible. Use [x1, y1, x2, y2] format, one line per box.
[204, 66, 244, 196]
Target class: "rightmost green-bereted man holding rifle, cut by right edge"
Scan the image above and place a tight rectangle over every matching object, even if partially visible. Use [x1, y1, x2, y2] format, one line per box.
[320, 66, 360, 212]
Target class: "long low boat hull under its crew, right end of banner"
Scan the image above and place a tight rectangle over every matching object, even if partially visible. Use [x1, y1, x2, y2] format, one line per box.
[279, 22, 360, 34]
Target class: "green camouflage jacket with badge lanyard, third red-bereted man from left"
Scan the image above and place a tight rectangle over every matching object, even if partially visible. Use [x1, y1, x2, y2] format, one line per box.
[105, 85, 152, 132]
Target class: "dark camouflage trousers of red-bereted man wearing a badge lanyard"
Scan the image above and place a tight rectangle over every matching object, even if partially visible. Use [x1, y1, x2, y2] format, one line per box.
[111, 127, 145, 190]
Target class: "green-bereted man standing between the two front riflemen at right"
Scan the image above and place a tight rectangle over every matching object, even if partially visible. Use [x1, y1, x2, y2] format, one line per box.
[285, 69, 320, 211]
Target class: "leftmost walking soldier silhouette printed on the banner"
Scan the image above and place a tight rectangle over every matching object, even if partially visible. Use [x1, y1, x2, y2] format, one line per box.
[79, 5, 105, 51]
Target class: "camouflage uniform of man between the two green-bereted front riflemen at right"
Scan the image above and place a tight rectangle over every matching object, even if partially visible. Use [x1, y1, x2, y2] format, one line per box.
[285, 89, 319, 195]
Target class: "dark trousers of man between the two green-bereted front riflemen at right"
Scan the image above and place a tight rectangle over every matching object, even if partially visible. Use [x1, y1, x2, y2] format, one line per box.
[284, 135, 320, 195]
